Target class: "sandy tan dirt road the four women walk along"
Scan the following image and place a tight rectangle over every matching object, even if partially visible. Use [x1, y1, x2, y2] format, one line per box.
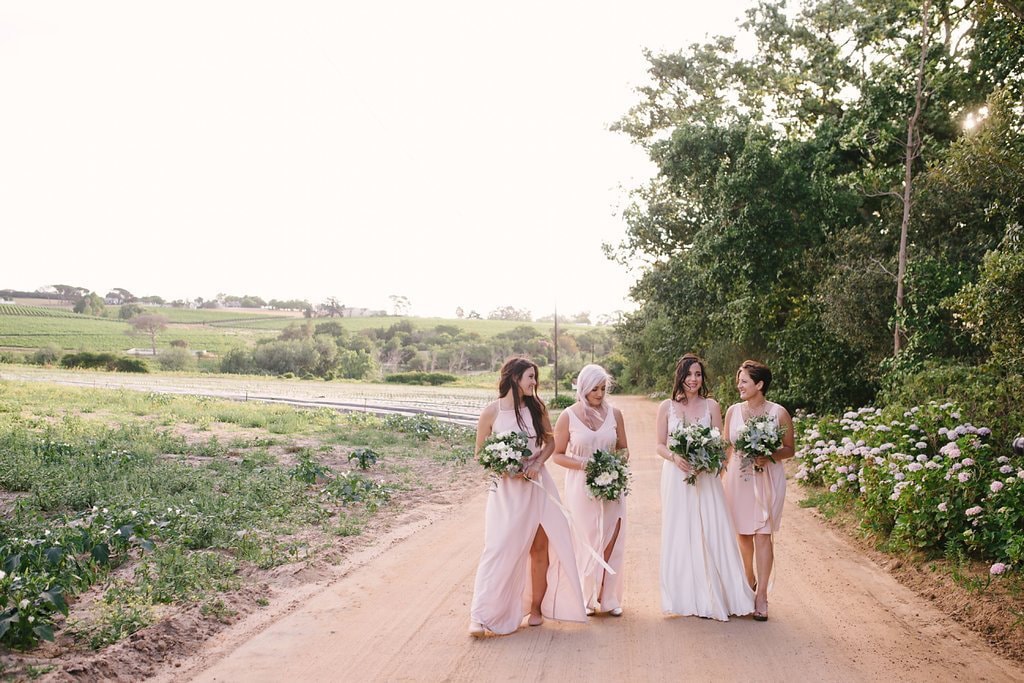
[153, 397, 1024, 682]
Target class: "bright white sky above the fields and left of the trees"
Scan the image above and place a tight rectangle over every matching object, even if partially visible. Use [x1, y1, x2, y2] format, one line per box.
[0, 0, 752, 316]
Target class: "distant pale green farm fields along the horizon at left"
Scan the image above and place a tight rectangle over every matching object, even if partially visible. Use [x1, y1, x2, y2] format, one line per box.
[0, 305, 590, 354]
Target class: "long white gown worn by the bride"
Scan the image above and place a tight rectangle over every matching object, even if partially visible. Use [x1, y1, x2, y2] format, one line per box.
[662, 402, 754, 622]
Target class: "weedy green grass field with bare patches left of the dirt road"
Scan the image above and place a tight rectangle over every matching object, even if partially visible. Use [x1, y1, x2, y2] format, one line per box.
[0, 381, 483, 663]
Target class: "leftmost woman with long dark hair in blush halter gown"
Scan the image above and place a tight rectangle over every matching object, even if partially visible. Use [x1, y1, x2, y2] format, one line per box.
[469, 356, 587, 637]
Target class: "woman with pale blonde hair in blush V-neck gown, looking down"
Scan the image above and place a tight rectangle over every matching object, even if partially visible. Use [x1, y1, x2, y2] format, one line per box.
[553, 365, 629, 616]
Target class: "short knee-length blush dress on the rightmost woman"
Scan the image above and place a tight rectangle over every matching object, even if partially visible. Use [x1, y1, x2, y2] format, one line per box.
[724, 403, 785, 535]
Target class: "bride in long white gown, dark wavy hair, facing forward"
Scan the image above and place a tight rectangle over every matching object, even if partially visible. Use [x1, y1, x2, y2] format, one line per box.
[656, 353, 754, 622]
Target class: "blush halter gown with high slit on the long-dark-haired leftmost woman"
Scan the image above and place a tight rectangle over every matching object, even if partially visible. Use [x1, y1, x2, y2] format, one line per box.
[470, 408, 587, 634]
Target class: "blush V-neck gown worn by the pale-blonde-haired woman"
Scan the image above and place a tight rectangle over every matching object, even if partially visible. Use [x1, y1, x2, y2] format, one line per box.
[565, 407, 626, 611]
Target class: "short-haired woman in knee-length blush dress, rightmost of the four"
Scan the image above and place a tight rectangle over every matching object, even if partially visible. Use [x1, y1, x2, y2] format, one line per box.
[724, 360, 795, 622]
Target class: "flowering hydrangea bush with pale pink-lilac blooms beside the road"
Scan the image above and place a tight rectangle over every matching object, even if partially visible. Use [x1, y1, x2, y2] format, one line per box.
[796, 401, 1024, 574]
